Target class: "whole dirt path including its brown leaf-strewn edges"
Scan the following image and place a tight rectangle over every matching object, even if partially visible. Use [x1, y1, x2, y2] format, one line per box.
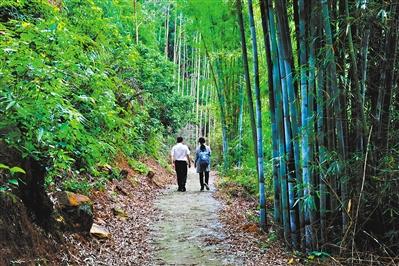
[54, 161, 288, 266]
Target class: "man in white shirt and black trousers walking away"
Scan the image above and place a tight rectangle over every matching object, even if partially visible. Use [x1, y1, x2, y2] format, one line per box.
[170, 137, 191, 192]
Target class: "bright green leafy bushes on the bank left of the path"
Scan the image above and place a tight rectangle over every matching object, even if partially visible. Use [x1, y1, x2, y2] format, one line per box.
[0, 0, 194, 192]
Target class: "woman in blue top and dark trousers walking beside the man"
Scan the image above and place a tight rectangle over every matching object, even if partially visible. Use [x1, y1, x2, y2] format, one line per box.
[194, 137, 211, 191]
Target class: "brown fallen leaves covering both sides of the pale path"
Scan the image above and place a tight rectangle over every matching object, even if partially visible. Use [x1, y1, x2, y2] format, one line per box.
[58, 159, 289, 265]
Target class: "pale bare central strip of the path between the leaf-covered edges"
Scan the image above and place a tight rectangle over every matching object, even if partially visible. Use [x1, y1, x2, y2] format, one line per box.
[152, 169, 239, 265]
